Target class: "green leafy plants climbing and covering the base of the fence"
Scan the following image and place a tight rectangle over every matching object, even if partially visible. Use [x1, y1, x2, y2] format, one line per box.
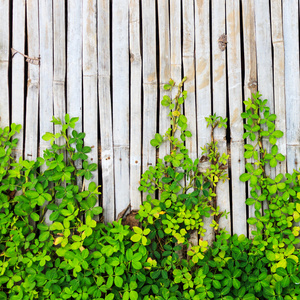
[0, 78, 300, 300]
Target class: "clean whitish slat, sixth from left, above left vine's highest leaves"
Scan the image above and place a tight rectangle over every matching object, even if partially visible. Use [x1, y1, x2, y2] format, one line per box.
[67, 0, 83, 189]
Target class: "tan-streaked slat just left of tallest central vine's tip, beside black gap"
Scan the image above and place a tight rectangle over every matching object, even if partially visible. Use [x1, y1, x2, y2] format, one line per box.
[157, 0, 172, 158]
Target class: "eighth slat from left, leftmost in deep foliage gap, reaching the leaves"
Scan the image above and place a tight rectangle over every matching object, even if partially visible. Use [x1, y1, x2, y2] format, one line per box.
[97, 0, 115, 222]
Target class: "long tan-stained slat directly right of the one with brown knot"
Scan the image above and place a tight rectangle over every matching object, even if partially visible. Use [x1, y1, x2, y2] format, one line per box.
[226, 0, 247, 236]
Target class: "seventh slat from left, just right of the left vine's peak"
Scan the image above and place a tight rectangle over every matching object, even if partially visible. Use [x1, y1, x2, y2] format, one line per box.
[82, 0, 99, 202]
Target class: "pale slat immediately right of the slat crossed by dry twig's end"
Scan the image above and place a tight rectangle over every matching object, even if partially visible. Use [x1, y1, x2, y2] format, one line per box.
[39, 0, 53, 225]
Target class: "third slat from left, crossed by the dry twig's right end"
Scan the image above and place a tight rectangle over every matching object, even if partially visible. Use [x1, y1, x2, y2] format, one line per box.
[24, 0, 40, 160]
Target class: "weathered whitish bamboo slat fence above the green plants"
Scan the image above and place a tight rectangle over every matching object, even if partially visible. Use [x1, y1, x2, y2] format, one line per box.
[0, 0, 300, 244]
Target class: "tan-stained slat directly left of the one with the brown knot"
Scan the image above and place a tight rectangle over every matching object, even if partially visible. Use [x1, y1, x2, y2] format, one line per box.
[195, 0, 215, 245]
